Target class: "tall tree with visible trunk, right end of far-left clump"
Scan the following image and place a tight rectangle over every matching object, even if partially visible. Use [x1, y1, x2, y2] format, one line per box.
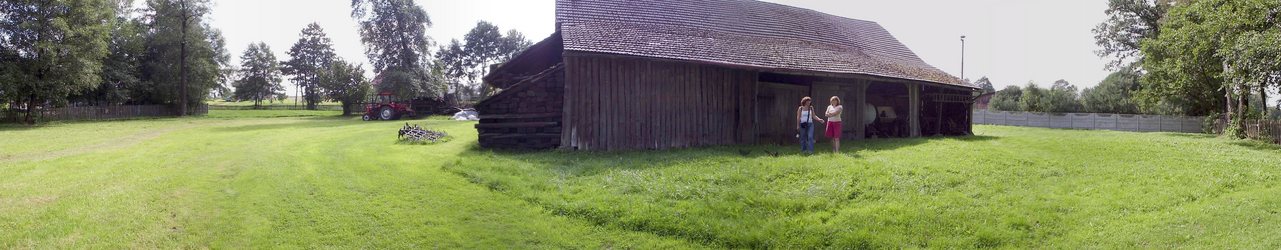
[139, 0, 231, 113]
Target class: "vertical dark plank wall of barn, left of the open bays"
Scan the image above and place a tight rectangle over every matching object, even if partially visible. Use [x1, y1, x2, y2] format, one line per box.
[561, 54, 757, 150]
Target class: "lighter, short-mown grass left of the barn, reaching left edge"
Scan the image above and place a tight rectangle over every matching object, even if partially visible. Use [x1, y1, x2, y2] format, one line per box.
[0, 115, 690, 249]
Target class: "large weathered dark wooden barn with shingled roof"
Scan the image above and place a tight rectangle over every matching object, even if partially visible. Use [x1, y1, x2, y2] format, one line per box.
[475, 0, 979, 150]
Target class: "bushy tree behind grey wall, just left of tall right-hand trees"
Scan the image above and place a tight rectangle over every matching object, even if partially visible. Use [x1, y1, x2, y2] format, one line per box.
[1081, 68, 1140, 114]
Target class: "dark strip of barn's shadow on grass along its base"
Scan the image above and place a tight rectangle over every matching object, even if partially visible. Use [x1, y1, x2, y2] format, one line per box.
[459, 136, 999, 177]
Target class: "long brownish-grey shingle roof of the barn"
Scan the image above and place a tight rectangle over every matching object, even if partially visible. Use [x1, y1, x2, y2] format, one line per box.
[556, 0, 972, 87]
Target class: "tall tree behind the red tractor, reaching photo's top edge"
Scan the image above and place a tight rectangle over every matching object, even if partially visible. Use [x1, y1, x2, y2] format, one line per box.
[351, 0, 443, 96]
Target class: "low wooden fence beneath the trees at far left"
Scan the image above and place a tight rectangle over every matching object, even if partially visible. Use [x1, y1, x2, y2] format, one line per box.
[0, 105, 209, 122]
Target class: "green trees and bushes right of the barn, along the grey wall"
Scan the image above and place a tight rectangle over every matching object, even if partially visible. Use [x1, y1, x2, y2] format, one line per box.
[973, 0, 1281, 137]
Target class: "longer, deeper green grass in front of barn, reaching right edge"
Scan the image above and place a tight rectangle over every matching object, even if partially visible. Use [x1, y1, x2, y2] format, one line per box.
[446, 127, 1281, 249]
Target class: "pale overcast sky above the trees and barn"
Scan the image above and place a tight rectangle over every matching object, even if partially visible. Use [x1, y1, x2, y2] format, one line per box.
[199, 0, 1108, 90]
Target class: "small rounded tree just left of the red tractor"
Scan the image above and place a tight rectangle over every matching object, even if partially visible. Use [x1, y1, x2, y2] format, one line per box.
[319, 60, 370, 115]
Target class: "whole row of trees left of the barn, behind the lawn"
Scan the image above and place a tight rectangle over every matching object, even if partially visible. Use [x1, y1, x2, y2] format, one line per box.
[0, 0, 532, 122]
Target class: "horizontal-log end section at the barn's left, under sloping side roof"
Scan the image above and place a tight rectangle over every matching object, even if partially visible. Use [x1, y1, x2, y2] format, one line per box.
[477, 68, 565, 149]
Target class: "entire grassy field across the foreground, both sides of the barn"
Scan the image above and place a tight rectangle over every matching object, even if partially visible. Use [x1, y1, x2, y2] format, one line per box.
[0, 110, 1281, 249]
